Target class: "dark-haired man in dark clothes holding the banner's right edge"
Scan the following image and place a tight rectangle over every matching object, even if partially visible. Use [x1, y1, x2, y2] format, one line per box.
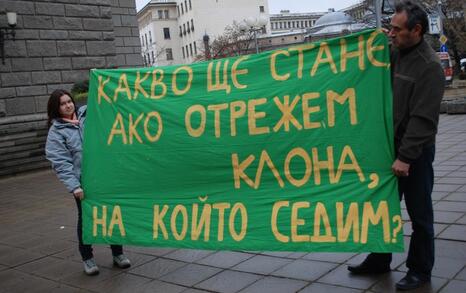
[348, 1, 445, 290]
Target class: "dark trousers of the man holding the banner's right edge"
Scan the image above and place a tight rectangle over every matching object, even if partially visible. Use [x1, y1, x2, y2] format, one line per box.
[368, 146, 435, 280]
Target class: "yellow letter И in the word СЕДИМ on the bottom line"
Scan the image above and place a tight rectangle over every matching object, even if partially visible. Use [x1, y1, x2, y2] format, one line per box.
[336, 202, 359, 243]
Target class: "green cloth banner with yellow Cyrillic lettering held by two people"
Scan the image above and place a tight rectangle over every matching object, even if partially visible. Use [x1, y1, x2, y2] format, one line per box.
[82, 30, 403, 252]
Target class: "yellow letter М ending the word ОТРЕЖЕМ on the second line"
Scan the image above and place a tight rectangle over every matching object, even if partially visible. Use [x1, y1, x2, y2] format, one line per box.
[327, 88, 358, 127]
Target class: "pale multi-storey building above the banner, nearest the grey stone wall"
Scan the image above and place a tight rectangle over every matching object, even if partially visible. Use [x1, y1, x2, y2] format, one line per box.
[137, 0, 271, 66]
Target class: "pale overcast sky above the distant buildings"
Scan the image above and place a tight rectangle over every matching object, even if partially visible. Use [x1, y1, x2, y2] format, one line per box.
[136, 0, 360, 13]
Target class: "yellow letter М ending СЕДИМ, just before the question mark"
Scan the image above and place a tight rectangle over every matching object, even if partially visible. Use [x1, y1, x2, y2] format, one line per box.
[361, 201, 390, 244]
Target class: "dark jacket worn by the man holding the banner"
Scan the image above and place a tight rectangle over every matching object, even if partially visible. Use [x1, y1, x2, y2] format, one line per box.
[391, 40, 445, 163]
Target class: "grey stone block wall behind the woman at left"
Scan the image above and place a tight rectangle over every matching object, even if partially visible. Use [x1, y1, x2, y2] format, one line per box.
[0, 0, 143, 176]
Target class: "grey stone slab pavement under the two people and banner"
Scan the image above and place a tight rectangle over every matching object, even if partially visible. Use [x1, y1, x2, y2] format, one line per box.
[0, 115, 466, 293]
